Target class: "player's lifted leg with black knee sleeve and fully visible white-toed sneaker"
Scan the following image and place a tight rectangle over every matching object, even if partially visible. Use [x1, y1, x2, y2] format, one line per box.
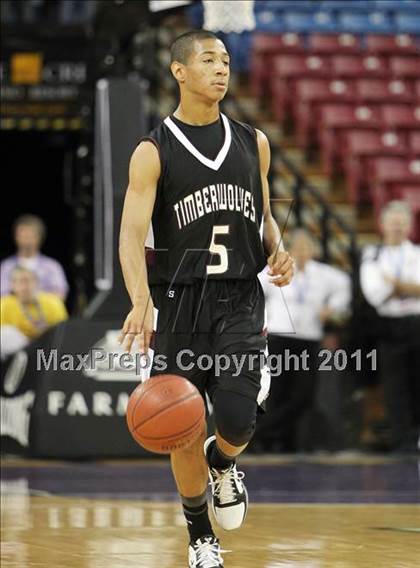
[204, 279, 270, 530]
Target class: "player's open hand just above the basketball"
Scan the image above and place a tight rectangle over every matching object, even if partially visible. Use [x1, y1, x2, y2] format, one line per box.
[118, 297, 153, 354]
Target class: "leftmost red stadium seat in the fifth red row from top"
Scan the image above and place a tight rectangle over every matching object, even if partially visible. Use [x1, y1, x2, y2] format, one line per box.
[340, 130, 408, 203]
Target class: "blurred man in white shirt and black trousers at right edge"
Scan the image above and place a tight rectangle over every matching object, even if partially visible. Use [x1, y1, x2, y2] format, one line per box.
[360, 201, 420, 451]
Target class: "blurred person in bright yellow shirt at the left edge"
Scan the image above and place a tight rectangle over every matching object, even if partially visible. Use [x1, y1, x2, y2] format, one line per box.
[0, 266, 68, 359]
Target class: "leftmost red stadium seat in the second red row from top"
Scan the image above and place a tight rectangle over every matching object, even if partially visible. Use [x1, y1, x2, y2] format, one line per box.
[270, 55, 331, 120]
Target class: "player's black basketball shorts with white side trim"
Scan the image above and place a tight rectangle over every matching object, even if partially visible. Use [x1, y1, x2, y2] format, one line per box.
[151, 278, 270, 409]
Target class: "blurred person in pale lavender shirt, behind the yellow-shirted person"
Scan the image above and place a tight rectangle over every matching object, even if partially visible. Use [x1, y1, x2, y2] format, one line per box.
[0, 215, 69, 300]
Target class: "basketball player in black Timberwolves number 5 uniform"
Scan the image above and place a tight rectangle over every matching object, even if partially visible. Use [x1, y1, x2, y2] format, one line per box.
[120, 30, 293, 568]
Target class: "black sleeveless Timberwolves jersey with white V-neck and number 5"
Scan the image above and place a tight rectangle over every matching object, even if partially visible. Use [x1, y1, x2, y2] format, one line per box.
[141, 114, 266, 284]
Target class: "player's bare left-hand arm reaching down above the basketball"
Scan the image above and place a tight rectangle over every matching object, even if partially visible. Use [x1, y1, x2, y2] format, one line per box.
[119, 141, 160, 353]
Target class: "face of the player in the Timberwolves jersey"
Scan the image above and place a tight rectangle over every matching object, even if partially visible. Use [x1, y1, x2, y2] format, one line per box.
[184, 39, 230, 101]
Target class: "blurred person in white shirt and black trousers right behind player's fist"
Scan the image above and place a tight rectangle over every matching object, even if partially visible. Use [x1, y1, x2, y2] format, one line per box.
[257, 229, 351, 451]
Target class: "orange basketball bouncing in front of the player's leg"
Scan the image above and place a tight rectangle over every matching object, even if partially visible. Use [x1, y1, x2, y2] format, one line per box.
[127, 375, 206, 454]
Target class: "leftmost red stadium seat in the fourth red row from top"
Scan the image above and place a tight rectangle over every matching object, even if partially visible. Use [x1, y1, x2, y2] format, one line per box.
[318, 104, 382, 175]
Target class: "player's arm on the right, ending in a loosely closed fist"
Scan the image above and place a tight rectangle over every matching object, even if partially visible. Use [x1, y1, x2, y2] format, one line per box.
[256, 130, 293, 286]
